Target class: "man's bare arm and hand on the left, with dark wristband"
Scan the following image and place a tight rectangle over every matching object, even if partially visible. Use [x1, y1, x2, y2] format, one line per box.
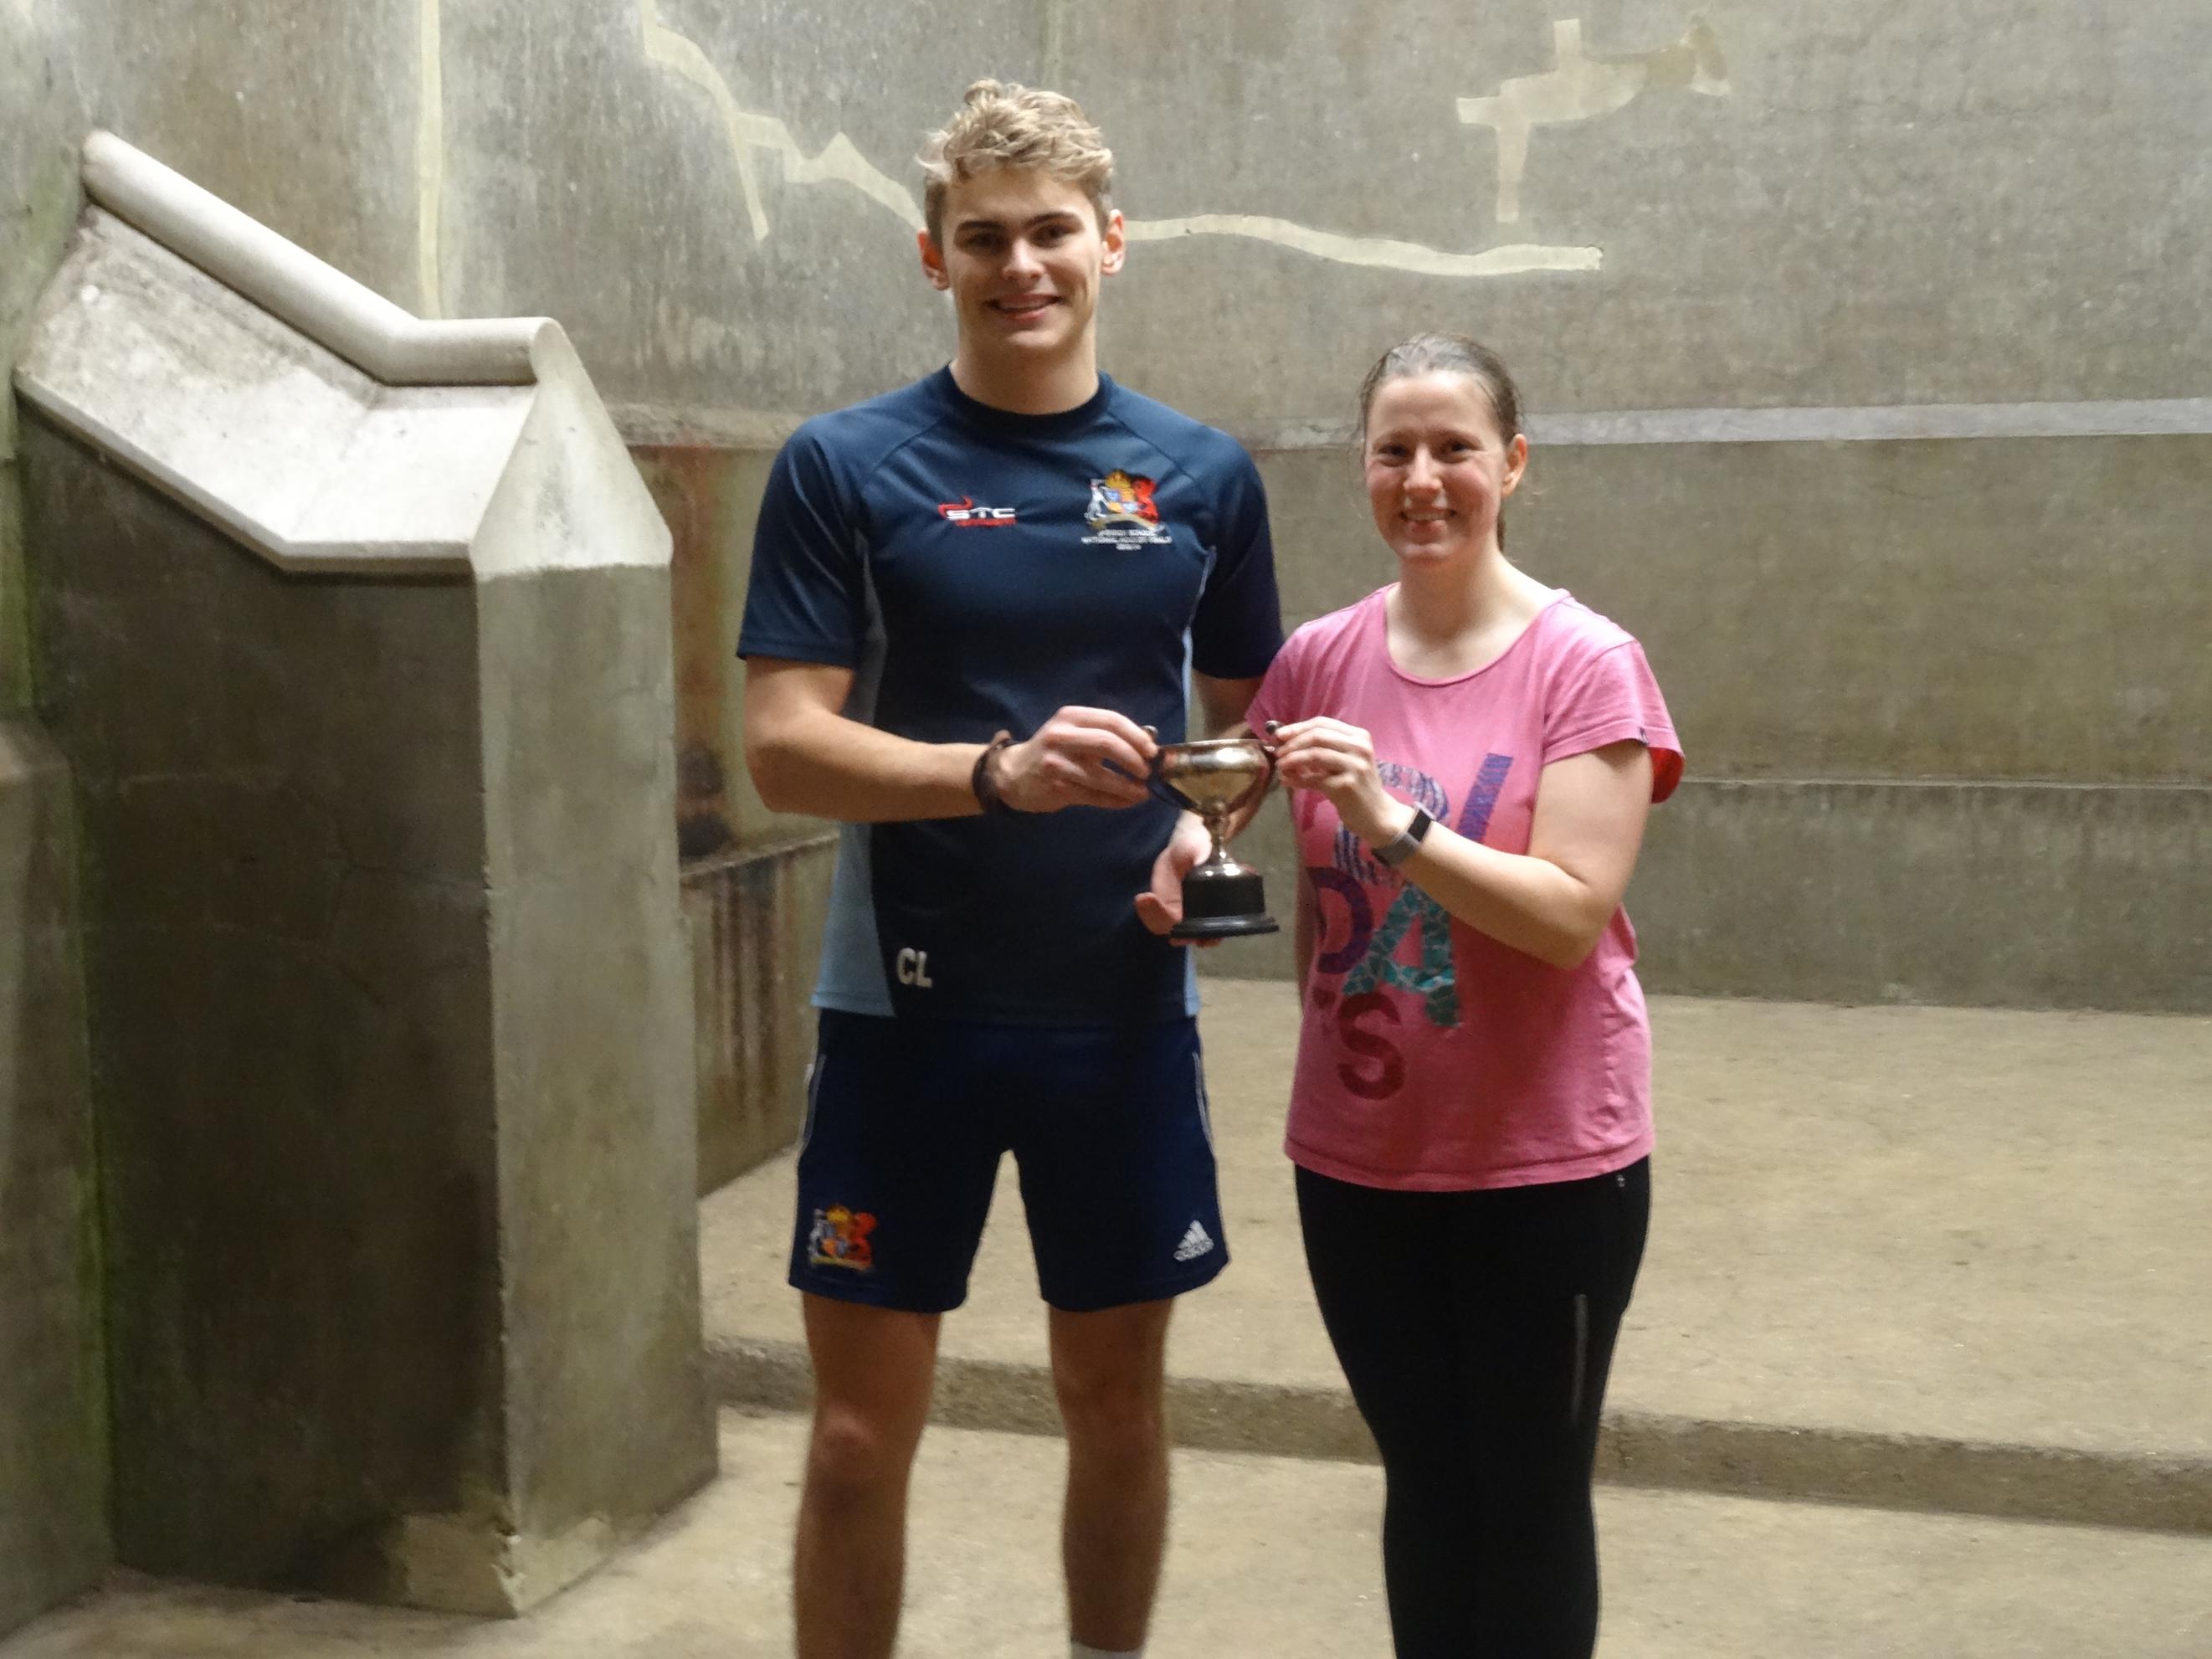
[746, 657, 1158, 823]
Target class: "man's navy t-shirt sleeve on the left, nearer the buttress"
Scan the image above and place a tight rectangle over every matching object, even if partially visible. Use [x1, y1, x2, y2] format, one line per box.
[736, 427, 867, 668]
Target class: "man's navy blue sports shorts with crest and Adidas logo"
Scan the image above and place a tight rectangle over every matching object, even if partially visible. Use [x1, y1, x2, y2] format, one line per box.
[792, 1009, 1228, 1314]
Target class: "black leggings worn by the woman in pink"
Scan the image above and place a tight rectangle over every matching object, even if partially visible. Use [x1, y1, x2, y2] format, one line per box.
[1298, 1159, 1650, 1659]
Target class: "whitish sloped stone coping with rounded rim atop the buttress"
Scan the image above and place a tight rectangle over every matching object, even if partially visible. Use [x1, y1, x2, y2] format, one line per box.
[16, 133, 670, 582]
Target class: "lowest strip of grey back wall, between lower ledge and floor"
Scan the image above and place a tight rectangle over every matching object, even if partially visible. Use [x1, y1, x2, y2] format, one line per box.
[1199, 777, 2212, 1013]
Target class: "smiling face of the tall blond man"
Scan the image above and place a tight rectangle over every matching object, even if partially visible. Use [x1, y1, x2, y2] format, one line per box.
[920, 168, 1124, 362]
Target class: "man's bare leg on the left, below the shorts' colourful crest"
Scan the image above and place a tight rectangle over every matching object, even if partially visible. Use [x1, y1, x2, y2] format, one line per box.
[792, 1297, 940, 1659]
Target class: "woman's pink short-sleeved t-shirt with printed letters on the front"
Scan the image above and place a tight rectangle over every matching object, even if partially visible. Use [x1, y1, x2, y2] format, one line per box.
[1248, 588, 1681, 1192]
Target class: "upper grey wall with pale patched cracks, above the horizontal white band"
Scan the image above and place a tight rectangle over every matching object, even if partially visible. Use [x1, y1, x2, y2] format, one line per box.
[407, 0, 2212, 424]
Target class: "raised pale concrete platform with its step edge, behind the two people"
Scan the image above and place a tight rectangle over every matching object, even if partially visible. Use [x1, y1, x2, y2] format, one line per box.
[701, 980, 2212, 1533]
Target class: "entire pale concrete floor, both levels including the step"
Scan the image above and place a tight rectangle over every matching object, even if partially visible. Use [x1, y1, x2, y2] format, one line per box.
[17, 982, 2212, 1659]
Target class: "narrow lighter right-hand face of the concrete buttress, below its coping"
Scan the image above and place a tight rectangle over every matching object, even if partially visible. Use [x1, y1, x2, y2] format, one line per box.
[475, 555, 716, 1608]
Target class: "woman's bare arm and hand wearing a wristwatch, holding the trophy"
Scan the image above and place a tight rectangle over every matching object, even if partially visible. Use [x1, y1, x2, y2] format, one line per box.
[1276, 719, 1652, 968]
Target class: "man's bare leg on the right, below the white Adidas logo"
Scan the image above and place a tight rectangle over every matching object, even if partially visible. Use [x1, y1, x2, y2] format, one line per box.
[1050, 1301, 1174, 1652]
